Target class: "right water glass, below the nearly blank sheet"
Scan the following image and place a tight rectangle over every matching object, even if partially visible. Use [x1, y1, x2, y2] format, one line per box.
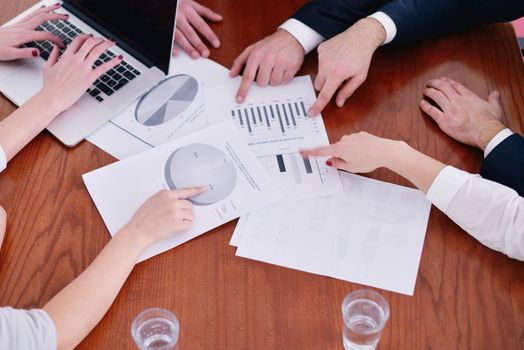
[342, 289, 389, 350]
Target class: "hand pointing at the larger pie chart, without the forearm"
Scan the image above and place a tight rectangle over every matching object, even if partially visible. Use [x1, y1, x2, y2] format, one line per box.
[125, 187, 207, 247]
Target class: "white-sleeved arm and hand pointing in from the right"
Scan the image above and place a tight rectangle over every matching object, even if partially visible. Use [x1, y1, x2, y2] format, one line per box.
[304, 132, 524, 261]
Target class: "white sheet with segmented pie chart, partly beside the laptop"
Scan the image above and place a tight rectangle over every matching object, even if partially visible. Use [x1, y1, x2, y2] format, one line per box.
[87, 50, 229, 159]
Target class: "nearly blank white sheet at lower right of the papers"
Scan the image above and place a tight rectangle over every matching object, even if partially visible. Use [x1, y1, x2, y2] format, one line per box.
[235, 173, 431, 295]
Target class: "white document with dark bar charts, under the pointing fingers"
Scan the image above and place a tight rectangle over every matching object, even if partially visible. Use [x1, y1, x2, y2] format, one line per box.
[204, 76, 342, 200]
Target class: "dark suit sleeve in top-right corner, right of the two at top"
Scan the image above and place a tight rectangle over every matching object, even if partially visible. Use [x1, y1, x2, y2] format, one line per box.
[379, 0, 524, 42]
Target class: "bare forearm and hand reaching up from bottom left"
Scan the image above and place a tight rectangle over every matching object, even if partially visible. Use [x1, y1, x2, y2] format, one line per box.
[44, 188, 205, 349]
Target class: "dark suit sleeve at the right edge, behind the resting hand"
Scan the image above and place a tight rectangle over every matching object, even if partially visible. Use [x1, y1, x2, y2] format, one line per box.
[480, 134, 524, 197]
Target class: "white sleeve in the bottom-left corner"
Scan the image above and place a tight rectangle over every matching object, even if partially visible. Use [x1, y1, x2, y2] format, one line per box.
[0, 307, 57, 350]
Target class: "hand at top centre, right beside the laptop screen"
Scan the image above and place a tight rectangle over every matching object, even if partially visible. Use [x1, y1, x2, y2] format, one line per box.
[173, 0, 222, 58]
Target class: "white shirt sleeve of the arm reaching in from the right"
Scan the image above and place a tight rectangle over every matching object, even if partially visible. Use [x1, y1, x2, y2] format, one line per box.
[426, 166, 524, 261]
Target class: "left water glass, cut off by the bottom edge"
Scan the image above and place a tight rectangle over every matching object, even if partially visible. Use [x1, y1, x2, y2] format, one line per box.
[131, 307, 180, 350]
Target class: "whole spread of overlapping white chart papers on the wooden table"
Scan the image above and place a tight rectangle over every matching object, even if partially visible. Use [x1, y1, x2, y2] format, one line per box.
[84, 50, 430, 294]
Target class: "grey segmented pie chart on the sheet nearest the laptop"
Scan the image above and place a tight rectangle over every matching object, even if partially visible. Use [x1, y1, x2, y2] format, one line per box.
[135, 74, 198, 126]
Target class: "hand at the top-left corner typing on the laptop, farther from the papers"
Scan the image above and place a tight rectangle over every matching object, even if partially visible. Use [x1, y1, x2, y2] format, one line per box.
[0, 5, 68, 61]
